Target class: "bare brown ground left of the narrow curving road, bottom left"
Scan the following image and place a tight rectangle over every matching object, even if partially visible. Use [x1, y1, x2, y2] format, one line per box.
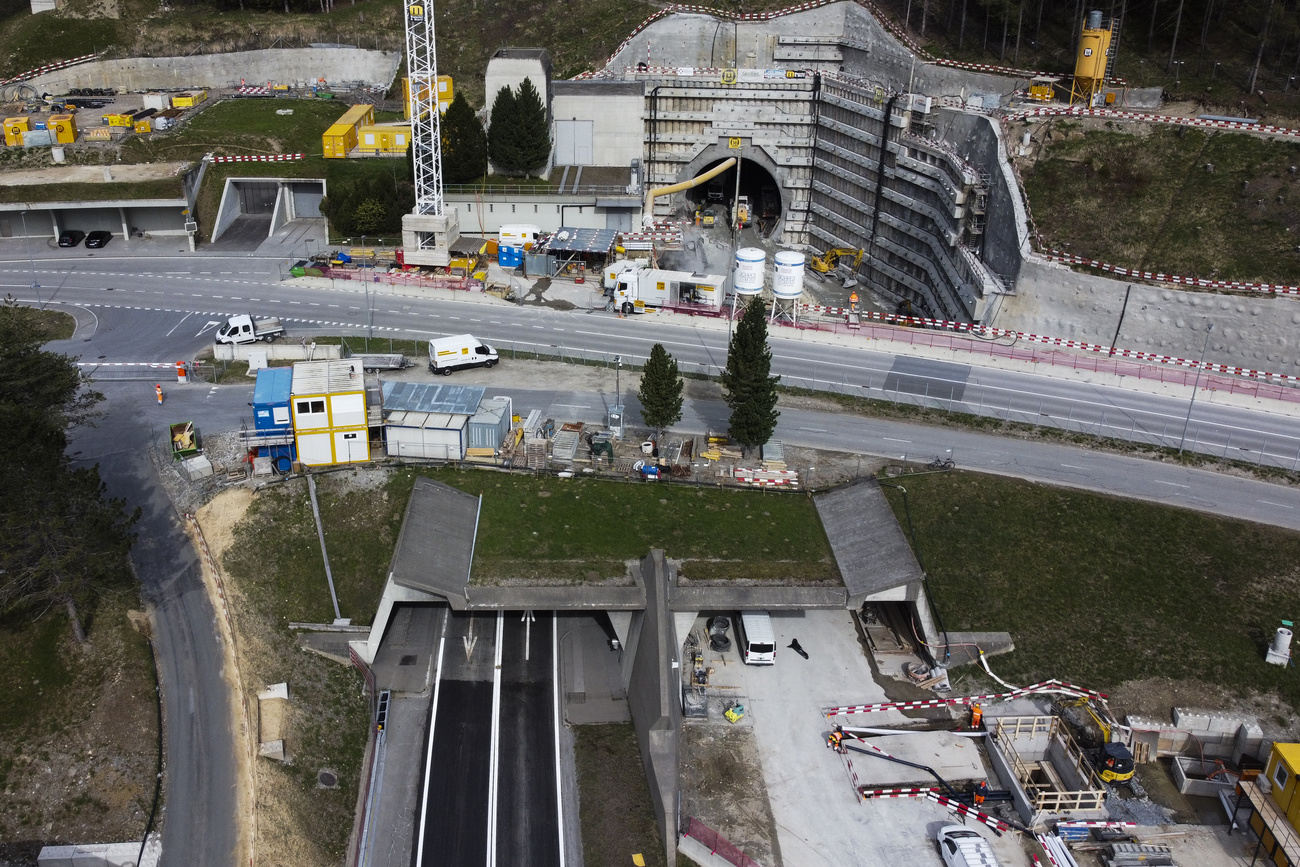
[0, 590, 159, 864]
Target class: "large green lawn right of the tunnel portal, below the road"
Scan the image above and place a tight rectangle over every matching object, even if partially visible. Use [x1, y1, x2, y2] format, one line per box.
[885, 472, 1300, 707]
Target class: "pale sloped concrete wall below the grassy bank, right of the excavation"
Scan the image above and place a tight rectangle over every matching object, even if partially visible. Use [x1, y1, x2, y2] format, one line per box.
[992, 257, 1300, 376]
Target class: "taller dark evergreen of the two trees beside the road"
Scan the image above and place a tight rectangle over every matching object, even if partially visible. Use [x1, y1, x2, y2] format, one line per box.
[722, 298, 781, 448]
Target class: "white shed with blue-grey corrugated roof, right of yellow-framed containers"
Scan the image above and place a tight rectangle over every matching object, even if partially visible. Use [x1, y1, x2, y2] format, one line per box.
[384, 381, 484, 460]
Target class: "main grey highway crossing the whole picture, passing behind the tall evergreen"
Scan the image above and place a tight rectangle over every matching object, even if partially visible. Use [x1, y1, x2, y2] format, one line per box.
[10, 260, 1300, 469]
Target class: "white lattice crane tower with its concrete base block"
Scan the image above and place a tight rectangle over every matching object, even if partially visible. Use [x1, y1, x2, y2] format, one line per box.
[402, 0, 460, 266]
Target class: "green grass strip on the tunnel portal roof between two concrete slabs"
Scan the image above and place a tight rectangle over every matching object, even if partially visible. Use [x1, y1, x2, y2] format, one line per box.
[391, 469, 839, 584]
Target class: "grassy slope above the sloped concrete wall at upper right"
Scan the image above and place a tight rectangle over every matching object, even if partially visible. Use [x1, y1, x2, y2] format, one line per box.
[1024, 122, 1300, 282]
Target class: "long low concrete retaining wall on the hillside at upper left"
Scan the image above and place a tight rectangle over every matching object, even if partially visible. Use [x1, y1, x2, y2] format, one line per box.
[27, 48, 402, 94]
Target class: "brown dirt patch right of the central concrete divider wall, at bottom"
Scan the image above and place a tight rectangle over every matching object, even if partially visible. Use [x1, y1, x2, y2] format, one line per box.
[680, 723, 781, 864]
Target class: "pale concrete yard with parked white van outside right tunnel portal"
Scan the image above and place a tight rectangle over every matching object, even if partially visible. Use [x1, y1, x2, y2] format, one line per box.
[710, 611, 1030, 867]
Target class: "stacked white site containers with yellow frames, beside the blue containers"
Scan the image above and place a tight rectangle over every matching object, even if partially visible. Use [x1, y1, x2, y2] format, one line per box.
[291, 359, 371, 467]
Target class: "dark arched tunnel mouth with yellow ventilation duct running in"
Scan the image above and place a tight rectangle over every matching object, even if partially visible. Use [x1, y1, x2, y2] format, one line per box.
[680, 146, 789, 238]
